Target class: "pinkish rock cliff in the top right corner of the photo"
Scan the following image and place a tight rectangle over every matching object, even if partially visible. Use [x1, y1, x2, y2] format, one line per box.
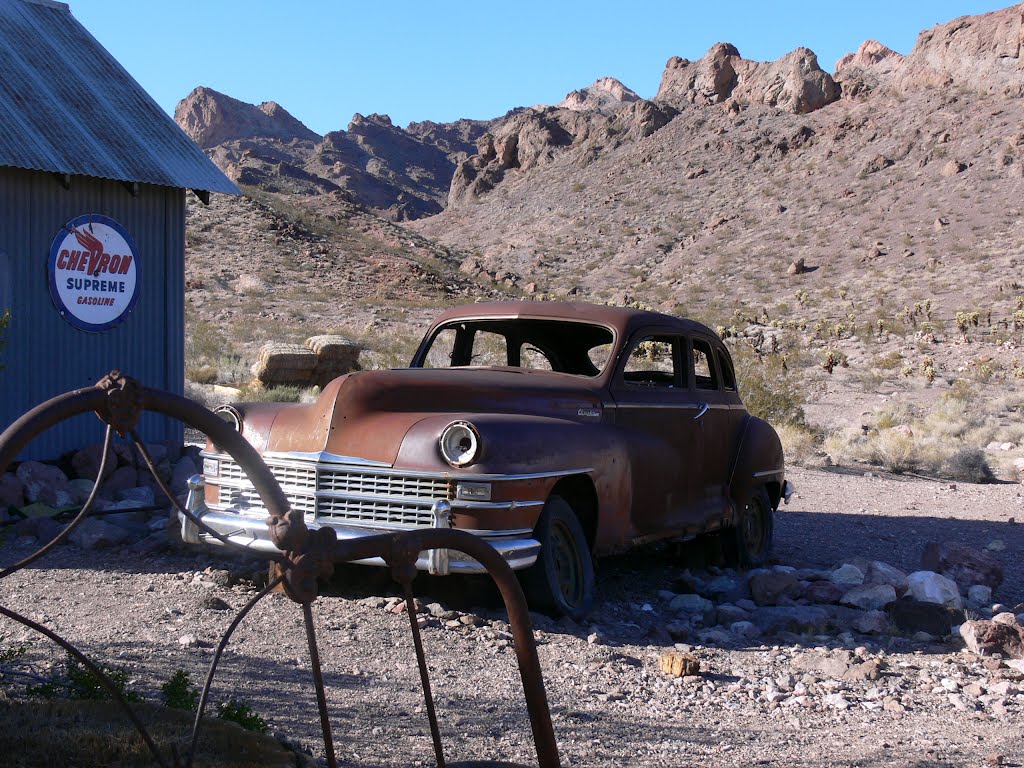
[895, 3, 1024, 96]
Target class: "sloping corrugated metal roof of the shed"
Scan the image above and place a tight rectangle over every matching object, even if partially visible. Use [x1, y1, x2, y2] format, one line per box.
[0, 0, 241, 195]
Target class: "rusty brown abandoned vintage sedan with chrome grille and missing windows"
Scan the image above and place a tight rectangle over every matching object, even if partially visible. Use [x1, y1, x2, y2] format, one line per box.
[182, 302, 791, 618]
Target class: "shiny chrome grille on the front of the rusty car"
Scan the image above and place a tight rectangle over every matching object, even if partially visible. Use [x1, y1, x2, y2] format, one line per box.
[207, 456, 455, 527]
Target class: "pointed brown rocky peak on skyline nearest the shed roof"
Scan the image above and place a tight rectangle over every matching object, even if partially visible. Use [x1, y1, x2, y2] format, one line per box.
[174, 86, 321, 150]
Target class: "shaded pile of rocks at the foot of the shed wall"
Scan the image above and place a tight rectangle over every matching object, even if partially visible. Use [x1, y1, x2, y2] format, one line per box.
[0, 441, 200, 549]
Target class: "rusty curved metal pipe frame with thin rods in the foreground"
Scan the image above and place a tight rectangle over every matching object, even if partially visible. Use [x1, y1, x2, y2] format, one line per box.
[0, 371, 560, 768]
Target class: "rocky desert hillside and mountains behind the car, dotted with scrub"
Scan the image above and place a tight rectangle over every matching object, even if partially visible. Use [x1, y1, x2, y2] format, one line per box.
[177, 4, 1024, 479]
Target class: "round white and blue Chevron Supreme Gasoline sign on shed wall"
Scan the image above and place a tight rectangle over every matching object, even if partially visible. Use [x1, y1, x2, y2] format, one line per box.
[47, 213, 139, 333]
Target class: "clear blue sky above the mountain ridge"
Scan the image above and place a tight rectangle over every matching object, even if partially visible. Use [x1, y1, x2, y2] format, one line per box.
[70, 0, 1012, 133]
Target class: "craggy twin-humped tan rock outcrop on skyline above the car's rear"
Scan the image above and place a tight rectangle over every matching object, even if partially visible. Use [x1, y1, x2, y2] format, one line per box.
[656, 43, 840, 115]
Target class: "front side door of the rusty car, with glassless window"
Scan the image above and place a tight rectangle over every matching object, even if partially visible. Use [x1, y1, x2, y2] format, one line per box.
[610, 330, 702, 538]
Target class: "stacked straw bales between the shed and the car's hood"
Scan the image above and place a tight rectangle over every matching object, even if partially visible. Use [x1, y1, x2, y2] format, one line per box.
[253, 336, 360, 387]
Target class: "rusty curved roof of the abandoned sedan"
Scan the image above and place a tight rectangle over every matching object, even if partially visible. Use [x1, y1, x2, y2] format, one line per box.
[434, 301, 715, 338]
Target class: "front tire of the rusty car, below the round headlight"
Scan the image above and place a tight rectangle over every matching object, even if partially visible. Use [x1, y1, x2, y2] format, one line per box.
[520, 496, 594, 622]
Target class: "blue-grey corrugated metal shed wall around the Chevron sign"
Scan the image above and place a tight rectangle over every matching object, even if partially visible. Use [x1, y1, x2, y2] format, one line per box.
[0, 168, 185, 459]
